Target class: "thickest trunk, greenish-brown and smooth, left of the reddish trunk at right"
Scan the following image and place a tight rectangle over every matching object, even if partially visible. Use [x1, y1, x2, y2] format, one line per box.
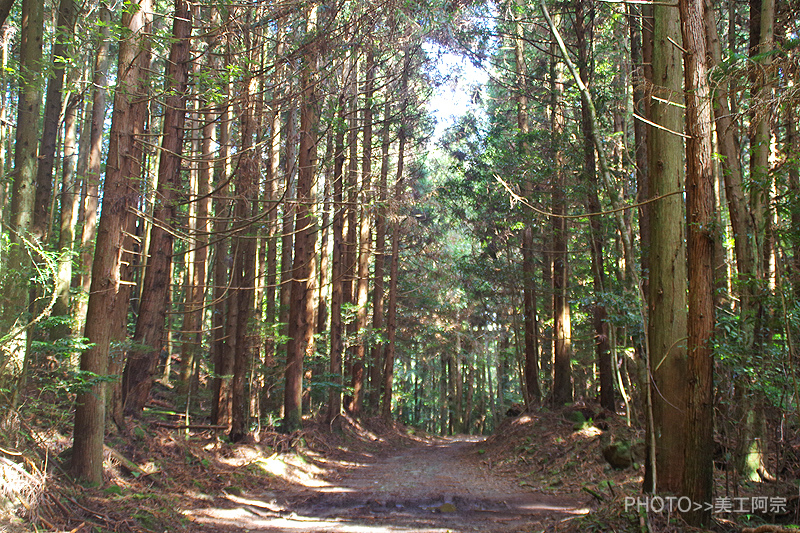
[647, 0, 687, 494]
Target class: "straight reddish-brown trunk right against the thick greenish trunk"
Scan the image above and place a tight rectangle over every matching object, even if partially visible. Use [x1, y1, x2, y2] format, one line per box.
[678, 0, 715, 526]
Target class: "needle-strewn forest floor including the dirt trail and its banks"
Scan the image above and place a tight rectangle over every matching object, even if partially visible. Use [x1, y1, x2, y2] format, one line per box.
[0, 404, 797, 533]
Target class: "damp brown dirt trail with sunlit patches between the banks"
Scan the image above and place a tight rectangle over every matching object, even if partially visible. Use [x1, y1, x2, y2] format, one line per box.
[188, 436, 586, 533]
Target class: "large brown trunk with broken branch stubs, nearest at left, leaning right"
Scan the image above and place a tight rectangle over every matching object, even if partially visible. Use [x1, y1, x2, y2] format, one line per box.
[71, 0, 152, 483]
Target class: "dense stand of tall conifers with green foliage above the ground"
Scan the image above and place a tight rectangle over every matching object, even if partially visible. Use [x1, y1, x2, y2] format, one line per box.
[0, 0, 800, 525]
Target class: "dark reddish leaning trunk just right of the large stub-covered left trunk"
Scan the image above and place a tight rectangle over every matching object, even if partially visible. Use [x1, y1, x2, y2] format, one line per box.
[122, 0, 192, 417]
